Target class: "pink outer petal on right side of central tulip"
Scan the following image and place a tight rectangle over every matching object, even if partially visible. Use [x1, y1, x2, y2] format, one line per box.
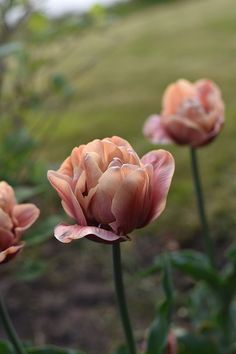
[142, 150, 175, 223]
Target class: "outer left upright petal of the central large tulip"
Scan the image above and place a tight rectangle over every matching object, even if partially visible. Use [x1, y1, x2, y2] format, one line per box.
[48, 171, 87, 226]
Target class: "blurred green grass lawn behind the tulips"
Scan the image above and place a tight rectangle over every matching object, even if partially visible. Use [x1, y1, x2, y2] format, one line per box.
[28, 0, 236, 241]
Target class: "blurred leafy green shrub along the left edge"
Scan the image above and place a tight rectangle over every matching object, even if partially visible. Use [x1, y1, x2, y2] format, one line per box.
[0, 0, 73, 281]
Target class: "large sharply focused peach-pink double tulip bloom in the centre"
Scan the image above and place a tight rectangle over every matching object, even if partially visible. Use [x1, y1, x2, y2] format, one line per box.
[48, 136, 174, 243]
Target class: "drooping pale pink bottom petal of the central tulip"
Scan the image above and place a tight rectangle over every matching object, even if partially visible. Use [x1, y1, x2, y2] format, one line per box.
[54, 224, 124, 243]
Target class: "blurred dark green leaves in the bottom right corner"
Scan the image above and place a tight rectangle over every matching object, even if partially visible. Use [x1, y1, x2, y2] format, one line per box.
[141, 248, 236, 354]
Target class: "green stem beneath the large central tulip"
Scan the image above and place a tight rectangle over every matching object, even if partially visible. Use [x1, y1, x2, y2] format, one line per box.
[112, 243, 136, 354]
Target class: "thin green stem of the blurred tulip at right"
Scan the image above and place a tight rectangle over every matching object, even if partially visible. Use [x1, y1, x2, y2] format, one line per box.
[190, 147, 214, 266]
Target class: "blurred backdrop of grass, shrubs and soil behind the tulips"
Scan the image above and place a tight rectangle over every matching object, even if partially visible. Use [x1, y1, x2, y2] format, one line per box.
[0, 0, 236, 354]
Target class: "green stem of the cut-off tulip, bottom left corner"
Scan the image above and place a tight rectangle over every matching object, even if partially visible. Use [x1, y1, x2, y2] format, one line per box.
[0, 295, 27, 354]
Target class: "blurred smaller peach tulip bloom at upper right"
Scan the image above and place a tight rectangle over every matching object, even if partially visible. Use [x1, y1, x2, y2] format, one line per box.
[143, 79, 224, 147]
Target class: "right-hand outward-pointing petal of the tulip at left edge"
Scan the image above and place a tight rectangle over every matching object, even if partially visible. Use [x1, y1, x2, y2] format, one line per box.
[12, 204, 40, 236]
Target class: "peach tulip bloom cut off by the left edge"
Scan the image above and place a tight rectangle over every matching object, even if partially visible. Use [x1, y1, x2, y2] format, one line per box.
[0, 181, 39, 263]
